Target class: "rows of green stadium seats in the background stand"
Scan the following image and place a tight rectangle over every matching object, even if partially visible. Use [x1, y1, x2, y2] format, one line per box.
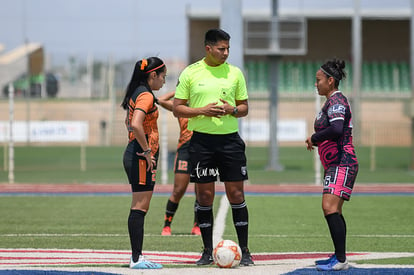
[245, 61, 410, 96]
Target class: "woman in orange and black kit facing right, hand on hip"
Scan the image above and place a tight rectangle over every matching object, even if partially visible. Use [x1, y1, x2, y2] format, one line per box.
[121, 57, 167, 269]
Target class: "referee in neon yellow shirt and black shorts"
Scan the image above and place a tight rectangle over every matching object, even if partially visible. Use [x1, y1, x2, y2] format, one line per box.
[173, 29, 253, 266]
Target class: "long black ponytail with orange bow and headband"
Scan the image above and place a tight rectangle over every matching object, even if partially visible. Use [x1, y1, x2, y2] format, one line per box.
[121, 57, 165, 110]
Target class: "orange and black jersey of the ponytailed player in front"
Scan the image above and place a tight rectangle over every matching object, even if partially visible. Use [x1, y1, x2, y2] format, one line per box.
[125, 86, 159, 155]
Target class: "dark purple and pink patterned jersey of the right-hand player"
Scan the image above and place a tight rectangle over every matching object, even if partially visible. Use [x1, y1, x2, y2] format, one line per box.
[314, 91, 358, 170]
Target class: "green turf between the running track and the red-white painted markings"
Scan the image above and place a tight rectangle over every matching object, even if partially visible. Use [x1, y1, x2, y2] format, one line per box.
[0, 195, 414, 256]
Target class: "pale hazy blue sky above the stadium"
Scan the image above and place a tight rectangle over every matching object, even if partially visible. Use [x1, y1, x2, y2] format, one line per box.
[0, 0, 410, 65]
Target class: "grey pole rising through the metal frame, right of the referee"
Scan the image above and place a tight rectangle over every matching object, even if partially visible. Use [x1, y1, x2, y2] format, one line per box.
[267, 0, 283, 171]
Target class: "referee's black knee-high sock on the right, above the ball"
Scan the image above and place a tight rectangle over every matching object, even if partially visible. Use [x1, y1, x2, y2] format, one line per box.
[231, 201, 249, 250]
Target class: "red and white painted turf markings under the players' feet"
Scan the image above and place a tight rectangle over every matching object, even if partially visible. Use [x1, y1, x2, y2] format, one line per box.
[0, 248, 414, 275]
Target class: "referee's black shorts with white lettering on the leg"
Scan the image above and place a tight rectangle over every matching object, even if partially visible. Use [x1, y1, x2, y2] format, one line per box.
[189, 132, 248, 183]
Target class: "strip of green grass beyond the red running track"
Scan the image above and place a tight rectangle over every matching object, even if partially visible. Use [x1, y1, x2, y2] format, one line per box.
[0, 146, 414, 184]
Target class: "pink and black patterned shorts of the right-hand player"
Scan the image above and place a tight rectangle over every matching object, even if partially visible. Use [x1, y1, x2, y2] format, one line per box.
[323, 165, 358, 201]
